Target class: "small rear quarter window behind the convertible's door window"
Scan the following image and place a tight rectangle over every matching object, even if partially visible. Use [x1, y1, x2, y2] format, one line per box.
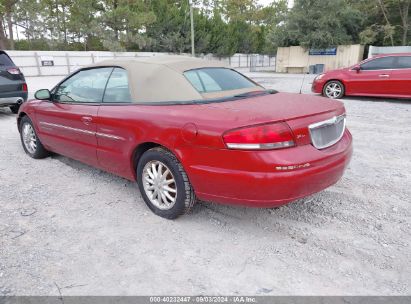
[103, 68, 131, 103]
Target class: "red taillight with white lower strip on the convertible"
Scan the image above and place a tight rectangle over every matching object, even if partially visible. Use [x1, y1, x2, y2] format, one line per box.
[223, 122, 295, 150]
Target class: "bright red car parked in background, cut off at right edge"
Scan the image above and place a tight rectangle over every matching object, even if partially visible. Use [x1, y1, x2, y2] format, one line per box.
[312, 53, 411, 99]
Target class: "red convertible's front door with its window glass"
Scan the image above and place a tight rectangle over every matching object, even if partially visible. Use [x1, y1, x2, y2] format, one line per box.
[36, 67, 113, 166]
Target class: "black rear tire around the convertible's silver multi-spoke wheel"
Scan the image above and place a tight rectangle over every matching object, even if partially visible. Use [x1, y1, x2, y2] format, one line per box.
[137, 147, 196, 219]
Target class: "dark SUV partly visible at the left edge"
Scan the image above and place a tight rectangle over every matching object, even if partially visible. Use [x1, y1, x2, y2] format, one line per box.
[0, 51, 27, 113]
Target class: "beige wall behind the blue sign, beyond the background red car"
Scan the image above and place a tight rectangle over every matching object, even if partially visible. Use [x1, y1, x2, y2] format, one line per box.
[276, 44, 364, 73]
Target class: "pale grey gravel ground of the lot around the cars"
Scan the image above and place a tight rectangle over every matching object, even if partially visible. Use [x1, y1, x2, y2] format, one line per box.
[0, 73, 411, 295]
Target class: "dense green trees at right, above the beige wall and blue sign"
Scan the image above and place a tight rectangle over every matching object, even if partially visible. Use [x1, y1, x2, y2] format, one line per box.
[266, 0, 411, 53]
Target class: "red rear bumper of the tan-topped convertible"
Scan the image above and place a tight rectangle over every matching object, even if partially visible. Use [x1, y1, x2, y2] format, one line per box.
[188, 130, 352, 207]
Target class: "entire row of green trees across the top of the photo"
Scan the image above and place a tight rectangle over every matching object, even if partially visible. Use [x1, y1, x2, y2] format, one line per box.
[0, 0, 411, 53]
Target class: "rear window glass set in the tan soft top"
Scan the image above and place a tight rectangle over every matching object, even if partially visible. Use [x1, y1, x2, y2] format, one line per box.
[184, 68, 257, 93]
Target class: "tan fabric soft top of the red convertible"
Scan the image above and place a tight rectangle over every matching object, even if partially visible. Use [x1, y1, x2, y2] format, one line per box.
[89, 55, 261, 102]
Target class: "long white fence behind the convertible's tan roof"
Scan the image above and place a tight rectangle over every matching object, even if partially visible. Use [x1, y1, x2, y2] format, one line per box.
[7, 51, 275, 77]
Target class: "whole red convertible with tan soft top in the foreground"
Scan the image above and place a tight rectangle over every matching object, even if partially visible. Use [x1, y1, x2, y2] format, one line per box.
[17, 56, 352, 219]
